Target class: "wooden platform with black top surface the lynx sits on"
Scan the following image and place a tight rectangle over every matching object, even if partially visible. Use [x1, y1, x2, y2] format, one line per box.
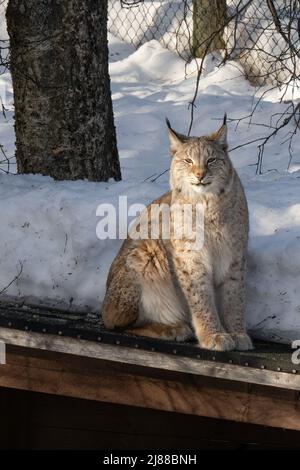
[0, 304, 300, 430]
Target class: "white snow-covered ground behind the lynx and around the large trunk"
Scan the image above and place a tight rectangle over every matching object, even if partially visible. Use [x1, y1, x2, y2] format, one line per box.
[0, 31, 300, 342]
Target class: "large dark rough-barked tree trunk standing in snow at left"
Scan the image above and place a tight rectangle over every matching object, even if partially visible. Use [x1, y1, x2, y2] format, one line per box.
[6, 0, 121, 181]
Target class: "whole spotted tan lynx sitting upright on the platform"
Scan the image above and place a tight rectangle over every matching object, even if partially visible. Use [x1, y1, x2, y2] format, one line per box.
[102, 116, 252, 351]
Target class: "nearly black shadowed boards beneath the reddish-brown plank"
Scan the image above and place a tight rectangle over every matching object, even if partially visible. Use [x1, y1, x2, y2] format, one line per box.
[0, 388, 300, 449]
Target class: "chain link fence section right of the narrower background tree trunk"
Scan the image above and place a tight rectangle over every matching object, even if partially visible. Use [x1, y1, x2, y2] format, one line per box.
[224, 0, 300, 86]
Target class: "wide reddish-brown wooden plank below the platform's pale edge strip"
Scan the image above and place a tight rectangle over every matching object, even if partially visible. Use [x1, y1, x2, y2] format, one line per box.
[0, 347, 300, 430]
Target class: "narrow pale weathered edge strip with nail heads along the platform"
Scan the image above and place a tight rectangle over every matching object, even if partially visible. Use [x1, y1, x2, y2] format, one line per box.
[0, 328, 300, 390]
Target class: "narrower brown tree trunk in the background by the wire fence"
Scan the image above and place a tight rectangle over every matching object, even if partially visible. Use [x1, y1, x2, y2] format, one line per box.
[193, 0, 226, 57]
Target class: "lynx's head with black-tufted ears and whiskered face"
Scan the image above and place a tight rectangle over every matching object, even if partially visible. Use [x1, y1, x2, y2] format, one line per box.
[167, 115, 233, 198]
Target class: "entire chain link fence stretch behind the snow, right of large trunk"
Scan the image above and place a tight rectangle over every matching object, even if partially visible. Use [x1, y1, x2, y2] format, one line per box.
[108, 0, 300, 85]
